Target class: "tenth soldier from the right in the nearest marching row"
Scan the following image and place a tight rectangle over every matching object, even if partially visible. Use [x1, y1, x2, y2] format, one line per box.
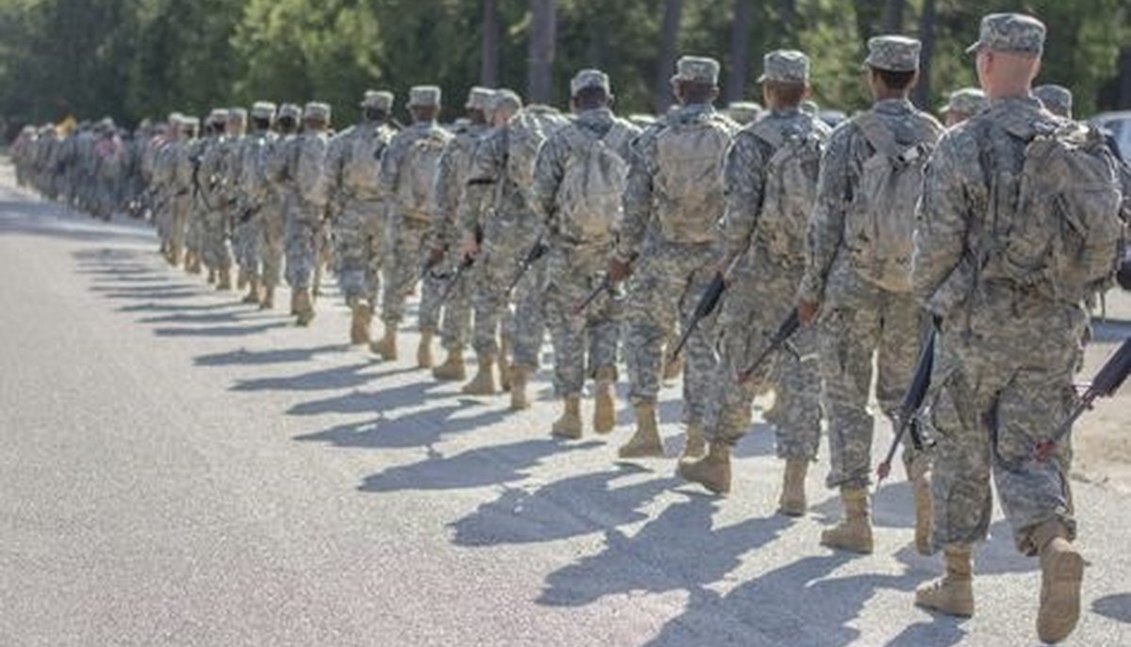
[286, 102, 330, 326]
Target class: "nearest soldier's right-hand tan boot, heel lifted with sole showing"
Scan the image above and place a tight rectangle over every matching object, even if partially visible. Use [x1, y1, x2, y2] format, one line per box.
[1033, 519, 1083, 642]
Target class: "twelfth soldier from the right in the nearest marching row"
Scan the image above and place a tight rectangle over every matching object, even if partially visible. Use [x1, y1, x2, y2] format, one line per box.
[232, 101, 276, 305]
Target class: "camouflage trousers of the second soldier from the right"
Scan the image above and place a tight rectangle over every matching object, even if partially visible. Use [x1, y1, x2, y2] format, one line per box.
[819, 273, 926, 488]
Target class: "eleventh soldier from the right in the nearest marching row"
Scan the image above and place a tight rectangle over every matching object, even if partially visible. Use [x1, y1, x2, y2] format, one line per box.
[259, 103, 302, 314]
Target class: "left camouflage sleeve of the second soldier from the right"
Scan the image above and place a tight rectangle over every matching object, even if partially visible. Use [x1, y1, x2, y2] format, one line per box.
[797, 126, 854, 303]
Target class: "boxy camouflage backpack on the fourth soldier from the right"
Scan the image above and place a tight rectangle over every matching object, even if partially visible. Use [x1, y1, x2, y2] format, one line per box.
[655, 114, 733, 243]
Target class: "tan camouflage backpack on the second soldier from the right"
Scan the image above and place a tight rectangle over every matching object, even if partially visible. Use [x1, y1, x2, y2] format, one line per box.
[845, 112, 940, 293]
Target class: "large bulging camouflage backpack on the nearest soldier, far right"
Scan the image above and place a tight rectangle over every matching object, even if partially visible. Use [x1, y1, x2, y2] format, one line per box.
[986, 122, 1125, 303]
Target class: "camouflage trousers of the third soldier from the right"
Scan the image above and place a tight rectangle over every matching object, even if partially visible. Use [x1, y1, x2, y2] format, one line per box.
[705, 248, 821, 460]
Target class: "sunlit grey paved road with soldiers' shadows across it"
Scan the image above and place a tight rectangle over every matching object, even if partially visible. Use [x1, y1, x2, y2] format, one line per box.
[0, 178, 1131, 646]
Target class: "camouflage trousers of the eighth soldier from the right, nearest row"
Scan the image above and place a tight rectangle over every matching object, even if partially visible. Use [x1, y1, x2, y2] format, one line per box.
[381, 218, 443, 331]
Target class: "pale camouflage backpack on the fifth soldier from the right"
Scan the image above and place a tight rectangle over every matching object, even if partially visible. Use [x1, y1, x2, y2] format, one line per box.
[556, 123, 629, 243]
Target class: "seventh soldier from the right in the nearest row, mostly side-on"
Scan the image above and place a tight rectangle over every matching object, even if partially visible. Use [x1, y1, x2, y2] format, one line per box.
[429, 87, 494, 381]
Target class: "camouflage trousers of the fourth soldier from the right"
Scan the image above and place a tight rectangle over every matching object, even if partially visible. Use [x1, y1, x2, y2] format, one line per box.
[624, 241, 718, 424]
